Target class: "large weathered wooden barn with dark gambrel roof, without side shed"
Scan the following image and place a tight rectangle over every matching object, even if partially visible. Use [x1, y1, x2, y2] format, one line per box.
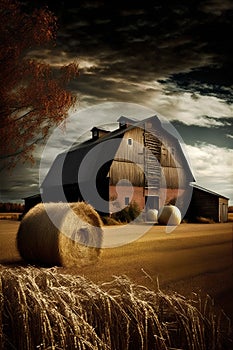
[42, 116, 195, 214]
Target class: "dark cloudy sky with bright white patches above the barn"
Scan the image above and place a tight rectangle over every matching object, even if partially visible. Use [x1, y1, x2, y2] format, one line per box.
[0, 0, 233, 205]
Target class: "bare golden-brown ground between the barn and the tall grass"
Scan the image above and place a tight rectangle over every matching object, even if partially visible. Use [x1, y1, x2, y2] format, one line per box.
[0, 220, 233, 319]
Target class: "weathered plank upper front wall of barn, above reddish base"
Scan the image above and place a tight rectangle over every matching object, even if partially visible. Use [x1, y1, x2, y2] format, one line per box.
[108, 124, 191, 190]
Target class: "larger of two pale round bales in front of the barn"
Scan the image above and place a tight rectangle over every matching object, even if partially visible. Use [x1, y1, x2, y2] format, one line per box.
[158, 205, 181, 226]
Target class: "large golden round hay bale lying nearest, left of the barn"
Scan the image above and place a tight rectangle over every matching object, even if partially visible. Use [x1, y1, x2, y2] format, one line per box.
[17, 202, 103, 267]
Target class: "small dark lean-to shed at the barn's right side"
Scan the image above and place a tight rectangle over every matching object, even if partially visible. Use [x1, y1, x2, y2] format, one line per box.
[186, 184, 229, 222]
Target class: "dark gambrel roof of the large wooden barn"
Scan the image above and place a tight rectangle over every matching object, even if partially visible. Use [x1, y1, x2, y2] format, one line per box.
[41, 116, 195, 188]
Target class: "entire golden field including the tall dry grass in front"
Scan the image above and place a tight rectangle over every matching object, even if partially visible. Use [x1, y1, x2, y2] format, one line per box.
[0, 220, 233, 350]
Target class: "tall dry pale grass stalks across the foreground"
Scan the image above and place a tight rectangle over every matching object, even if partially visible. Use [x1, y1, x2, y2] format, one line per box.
[0, 267, 232, 350]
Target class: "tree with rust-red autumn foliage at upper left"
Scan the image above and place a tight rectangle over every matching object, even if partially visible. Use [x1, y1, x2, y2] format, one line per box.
[0, 0, 78, 166]
